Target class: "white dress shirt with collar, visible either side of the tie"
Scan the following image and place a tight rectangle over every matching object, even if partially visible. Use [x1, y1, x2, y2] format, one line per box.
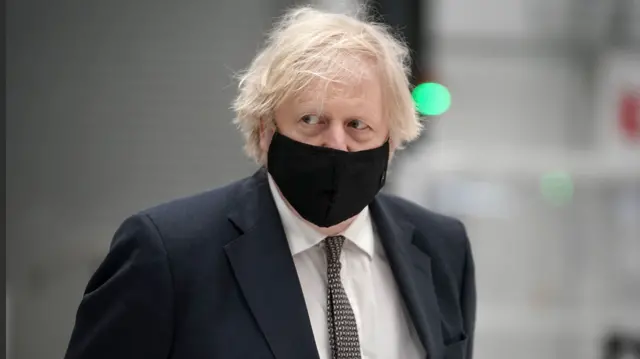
[269, 176, 426, 359]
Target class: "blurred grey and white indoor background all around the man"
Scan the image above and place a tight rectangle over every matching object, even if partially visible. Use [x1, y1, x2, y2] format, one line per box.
[6, 0, 640, 359]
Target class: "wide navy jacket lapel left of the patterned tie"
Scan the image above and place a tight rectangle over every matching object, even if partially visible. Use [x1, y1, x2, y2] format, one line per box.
[225, 170, 319, 359]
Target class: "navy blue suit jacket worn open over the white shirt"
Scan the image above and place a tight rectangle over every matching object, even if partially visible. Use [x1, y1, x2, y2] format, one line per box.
[66, 170, 476, 359]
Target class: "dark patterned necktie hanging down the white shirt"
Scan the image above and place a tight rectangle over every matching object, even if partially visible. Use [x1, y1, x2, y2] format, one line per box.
[324, 236, 361, 359]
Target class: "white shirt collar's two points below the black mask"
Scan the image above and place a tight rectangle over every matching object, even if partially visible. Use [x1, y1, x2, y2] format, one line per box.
[268, 175, 374, 259]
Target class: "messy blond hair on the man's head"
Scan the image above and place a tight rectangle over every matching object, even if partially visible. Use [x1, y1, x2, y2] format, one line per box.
[233, 6, 422, 164]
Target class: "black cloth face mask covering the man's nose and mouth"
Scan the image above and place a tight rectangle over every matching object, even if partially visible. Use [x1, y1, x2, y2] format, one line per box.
[267, 132, 389, 227]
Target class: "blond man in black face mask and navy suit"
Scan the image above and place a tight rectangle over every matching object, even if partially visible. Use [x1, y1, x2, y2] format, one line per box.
[66, 8, 476, 359]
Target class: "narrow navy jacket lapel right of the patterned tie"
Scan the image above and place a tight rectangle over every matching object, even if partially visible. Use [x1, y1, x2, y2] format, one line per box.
[370, 196, 444, 359]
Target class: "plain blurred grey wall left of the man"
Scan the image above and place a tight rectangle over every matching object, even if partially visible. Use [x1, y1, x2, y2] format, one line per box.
[6, 0, 283, 359]
